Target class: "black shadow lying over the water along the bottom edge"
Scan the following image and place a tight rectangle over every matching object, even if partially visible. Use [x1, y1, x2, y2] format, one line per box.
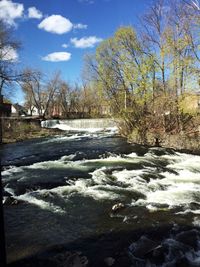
[8, 224, 200, 267]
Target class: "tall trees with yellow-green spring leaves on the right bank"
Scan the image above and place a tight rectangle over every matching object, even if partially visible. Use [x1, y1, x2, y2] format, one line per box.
[85, 0, 200, 143]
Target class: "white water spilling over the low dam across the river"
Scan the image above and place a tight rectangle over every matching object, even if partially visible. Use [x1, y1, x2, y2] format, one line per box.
[41, 119, 117, 131]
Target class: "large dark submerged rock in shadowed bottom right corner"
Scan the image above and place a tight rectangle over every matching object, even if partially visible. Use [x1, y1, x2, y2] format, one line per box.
[128, 229, 200, 267]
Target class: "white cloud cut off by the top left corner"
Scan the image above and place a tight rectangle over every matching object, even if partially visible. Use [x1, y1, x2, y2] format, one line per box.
[0, 0, 24, 26]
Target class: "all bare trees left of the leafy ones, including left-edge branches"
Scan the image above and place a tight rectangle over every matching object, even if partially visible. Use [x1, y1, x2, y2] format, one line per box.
[0, 20, 110, 120]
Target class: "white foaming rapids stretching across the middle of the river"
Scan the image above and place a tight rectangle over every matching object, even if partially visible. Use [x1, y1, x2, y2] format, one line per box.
[2, 151, 200, 214]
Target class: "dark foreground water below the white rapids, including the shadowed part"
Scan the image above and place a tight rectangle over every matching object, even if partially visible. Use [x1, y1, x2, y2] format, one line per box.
[6, 196, 200, 267]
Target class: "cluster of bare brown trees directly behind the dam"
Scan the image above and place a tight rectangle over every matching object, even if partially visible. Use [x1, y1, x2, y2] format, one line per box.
[20, 69, 109, 118]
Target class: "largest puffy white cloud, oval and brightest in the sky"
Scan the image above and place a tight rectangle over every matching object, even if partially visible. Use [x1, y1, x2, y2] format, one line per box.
[38, 15, 73, 34]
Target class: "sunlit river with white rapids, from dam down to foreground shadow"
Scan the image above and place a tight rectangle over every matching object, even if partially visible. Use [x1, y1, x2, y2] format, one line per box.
[0, 122, 200, 267]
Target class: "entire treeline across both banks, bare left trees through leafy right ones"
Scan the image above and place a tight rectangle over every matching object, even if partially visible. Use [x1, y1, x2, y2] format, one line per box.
[0, 0, 200, 138]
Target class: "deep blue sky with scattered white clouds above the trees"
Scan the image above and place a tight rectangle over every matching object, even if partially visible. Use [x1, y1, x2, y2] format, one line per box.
[0, 0, 151, 102]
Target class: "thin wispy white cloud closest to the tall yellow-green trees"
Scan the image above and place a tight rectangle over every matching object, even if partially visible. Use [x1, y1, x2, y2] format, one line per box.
[70, 36, 103, 48]
